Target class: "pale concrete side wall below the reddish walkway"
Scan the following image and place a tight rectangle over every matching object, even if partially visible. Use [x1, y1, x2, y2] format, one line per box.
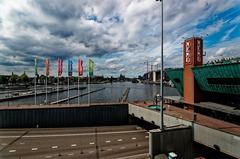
[128, 104, 240, 158]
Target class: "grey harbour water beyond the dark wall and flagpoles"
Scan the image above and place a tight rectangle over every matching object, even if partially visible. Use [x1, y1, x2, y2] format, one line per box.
[0, 82, 179, 106]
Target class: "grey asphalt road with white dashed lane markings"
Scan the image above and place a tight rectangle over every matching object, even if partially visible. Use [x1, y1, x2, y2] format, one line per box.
[0, 125, 149, 159]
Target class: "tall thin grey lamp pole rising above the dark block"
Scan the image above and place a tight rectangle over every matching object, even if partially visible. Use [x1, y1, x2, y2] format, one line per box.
[156, 0, 164, 130]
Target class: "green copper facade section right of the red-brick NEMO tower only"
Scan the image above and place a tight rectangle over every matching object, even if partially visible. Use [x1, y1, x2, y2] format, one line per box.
[192, 63, 240, 95]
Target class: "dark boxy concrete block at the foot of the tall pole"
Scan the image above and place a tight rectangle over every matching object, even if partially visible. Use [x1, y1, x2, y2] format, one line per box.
[149, 125, 194, 159]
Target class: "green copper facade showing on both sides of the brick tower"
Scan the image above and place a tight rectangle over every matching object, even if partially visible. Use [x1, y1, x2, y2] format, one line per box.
[166, 62, 240, 95]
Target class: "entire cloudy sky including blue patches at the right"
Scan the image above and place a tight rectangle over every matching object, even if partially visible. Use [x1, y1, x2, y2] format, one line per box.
[0, 0, 240, 77]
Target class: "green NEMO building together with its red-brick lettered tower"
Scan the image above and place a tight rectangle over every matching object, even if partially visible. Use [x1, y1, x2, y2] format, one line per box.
[166, 37, 240, 121]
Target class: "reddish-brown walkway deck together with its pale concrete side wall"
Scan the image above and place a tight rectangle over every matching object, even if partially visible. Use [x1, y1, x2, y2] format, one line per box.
[128, 102, 240, 158]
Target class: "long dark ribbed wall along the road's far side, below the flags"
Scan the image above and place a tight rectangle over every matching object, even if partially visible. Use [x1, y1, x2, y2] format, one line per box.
[0, 104, 128, 128]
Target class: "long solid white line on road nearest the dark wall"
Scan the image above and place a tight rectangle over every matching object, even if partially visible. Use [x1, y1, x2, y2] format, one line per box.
[0, 130, 146, 139]
